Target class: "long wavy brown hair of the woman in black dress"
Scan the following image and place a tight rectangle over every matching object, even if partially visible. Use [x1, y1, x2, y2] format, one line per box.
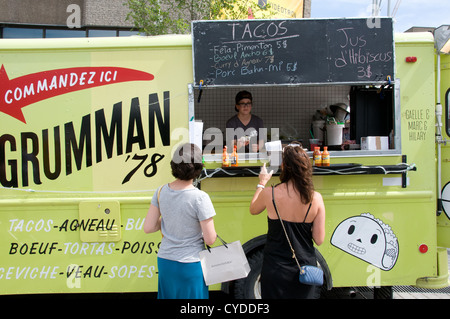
[280, 145, 314, 204]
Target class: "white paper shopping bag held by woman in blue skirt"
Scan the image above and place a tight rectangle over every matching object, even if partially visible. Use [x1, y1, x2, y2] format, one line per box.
[199, 240, 250, 286]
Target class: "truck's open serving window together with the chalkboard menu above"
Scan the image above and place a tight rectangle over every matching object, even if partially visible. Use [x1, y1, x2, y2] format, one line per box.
[190, 18, 401, 156]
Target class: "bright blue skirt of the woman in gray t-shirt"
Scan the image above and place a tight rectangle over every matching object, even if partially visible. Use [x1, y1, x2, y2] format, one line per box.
[158, 257, 209, 299]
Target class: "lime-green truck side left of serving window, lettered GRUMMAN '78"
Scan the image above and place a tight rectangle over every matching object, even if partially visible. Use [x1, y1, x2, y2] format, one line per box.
[0, 36, 192, 294]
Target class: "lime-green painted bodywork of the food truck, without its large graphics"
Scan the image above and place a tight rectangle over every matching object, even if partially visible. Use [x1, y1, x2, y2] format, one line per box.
[0, 33, 450, 294]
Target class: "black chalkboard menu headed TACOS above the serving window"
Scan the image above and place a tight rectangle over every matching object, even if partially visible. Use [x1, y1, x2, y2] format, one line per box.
[192, 18, 394, 86]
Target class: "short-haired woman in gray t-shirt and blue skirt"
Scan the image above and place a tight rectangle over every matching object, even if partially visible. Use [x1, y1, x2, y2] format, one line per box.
[144, 144, 217, 299]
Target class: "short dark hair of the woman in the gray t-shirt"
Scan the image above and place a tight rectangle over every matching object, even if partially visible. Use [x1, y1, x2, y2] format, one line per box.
[170, 143, 203, 181]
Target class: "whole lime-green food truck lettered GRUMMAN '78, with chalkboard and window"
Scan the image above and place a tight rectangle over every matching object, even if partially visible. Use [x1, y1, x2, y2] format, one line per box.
[0, 18, 450, 298]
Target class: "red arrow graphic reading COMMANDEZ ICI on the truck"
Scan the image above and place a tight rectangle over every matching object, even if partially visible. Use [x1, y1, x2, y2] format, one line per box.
[0, 65, 155, 123]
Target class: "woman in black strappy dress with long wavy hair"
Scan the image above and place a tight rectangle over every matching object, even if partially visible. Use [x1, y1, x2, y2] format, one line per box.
[250, 145, 325, 299]
